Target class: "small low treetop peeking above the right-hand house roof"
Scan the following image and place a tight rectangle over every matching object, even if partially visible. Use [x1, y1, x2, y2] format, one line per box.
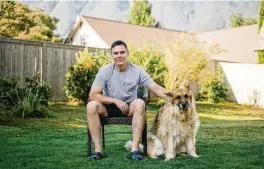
[230, 14, 257, 27]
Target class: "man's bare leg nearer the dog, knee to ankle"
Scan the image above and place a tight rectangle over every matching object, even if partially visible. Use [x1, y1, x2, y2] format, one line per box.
[128, 99, 146, 151]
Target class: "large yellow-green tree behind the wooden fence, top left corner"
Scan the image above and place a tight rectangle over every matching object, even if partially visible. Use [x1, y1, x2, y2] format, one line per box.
[0, 1, 62, 42]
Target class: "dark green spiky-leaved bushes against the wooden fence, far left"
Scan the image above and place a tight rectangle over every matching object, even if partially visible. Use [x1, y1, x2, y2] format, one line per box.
[0, 73, 52, 118]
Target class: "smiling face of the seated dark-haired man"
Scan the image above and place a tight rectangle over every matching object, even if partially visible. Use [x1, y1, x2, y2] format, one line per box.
[112, 45, 128, 66]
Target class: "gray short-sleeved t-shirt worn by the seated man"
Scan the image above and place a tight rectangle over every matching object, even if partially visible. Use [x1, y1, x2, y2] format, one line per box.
[92, 62, 154, 103]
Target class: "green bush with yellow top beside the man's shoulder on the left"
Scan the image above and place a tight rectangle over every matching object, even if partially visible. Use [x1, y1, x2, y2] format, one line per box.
[64, 48, 111, 104]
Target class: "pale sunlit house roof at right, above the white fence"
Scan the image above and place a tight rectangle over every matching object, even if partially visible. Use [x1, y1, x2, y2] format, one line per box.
[197, 24, 259, 63]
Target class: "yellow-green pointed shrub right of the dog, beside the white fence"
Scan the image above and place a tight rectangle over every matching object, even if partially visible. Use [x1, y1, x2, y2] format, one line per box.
[200, 66, 227, 103]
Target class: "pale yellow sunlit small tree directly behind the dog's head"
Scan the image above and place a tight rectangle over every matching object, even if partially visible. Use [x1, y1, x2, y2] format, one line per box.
[165, 33, 223, 90]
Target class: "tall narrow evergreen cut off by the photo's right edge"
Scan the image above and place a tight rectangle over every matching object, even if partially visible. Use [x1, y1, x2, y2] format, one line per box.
[257, 0, 264, 64]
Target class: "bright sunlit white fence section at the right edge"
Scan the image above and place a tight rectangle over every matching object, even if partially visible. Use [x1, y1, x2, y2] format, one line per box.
[219, 62, 264, 107]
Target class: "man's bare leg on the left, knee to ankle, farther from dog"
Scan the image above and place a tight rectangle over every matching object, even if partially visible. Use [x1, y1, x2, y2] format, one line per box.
[87, 101, 107, 153]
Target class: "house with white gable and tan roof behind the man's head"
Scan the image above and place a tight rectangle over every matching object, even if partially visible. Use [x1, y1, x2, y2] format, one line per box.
[64, 16, 184, 50]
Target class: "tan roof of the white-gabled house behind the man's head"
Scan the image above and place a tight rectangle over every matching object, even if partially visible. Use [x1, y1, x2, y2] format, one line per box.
[65, 16, 185, 49]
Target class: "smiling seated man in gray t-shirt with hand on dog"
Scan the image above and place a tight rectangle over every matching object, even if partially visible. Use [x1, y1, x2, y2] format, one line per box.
[87, 40, 169, 161]
